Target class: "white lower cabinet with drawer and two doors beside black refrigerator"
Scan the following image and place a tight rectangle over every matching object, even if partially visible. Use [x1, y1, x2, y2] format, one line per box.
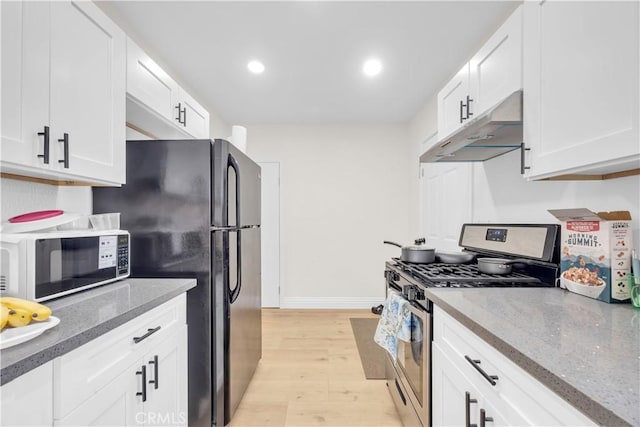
[54, 294, 187, 426]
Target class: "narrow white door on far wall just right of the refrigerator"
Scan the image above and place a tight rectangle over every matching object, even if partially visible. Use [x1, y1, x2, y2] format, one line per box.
[259, 162, 280, 307]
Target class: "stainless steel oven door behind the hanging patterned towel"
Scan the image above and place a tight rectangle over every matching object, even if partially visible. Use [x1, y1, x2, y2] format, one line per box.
[397, 302, 431, 426]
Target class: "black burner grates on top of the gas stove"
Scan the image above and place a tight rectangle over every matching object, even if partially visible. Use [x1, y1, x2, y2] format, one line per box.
[394, 258, 540, 287]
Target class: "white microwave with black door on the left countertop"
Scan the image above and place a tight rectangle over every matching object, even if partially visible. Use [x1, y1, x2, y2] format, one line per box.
[0, 230, 130, 301]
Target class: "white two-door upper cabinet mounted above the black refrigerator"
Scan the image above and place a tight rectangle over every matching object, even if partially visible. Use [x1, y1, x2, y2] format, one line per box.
[127, 38, 209, 139]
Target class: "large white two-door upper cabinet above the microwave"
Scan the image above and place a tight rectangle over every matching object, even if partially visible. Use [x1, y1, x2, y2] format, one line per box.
[1, 1, 126, 185]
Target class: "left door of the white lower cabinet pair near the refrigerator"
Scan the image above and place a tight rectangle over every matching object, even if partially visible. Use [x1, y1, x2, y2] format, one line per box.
[53, 364, 141, 426]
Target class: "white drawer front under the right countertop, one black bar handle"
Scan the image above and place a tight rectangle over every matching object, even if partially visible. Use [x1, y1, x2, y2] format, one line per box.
[433, 307, 594, 426]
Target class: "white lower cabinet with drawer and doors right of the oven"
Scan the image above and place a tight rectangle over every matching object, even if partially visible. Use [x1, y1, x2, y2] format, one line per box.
[432, 307, 595, 426]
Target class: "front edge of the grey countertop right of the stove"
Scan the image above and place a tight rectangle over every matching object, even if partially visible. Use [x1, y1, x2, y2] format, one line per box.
[425, 288, 632, 426]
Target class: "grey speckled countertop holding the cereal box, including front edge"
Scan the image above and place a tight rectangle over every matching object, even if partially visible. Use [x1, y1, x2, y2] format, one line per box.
[426, 288, 640, 426]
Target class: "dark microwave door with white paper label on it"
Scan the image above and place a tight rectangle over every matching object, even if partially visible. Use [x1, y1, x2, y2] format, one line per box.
[35, 236, 117, 298]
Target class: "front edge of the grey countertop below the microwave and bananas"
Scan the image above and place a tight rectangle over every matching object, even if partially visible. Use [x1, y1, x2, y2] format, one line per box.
[0, 279, 196, 386]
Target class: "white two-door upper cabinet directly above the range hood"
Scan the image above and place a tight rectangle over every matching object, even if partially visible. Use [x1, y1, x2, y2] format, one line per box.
[438, 6, 522, 137]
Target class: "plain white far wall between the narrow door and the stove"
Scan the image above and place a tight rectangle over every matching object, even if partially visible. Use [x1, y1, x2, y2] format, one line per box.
[247, 125, 415, 307]
